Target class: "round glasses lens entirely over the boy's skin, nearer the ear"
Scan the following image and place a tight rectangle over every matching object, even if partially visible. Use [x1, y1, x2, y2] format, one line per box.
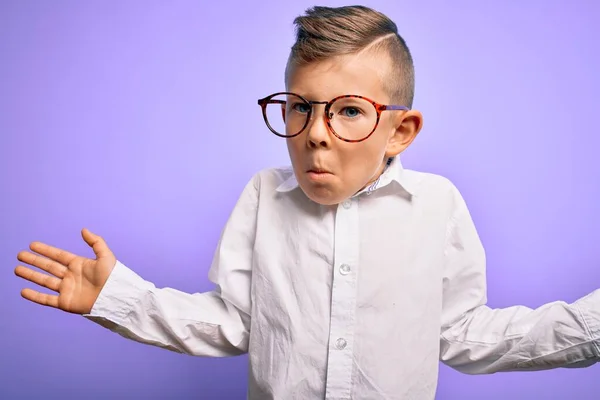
[329, 97, 377, 140]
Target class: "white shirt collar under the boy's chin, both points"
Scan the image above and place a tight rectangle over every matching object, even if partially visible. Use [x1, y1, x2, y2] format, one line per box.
[276, 156, 417, 196]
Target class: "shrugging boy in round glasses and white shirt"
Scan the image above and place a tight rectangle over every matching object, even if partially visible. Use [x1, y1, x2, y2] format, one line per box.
[15, 6, 600, 400]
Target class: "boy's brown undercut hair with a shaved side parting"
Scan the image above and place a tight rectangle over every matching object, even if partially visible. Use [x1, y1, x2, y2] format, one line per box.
[285, 6, 415, 108]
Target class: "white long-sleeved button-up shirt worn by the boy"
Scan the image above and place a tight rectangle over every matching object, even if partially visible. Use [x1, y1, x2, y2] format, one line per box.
[86, 158, 600, 400]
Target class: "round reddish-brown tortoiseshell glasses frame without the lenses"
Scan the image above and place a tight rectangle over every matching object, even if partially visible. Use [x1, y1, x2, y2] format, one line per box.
[258, 92, 409, 143]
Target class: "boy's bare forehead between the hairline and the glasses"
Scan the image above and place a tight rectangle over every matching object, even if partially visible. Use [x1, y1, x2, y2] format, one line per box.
[286, 52, 390, 102]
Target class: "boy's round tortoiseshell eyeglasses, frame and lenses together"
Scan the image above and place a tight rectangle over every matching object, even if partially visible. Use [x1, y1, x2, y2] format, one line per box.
[258, 92, 408, 143]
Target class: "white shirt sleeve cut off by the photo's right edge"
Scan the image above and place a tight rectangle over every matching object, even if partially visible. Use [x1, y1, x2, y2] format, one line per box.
[440, 181, 600, 374]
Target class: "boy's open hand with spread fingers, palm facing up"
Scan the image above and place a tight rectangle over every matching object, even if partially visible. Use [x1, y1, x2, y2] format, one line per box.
[15, 230, 116, 314]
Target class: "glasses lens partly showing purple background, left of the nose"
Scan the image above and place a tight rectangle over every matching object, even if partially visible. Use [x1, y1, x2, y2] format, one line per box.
[265, 94, 311, 136]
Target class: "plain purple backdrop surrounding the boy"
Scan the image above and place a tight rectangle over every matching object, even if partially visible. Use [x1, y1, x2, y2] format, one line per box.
[0, 0, 600, 400]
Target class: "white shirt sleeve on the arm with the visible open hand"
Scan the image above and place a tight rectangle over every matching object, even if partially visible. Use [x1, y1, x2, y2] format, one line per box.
[84, 177, 258, 357]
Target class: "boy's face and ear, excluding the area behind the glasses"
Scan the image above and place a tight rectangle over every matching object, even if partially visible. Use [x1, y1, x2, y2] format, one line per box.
[286, 52, 422, 205]
